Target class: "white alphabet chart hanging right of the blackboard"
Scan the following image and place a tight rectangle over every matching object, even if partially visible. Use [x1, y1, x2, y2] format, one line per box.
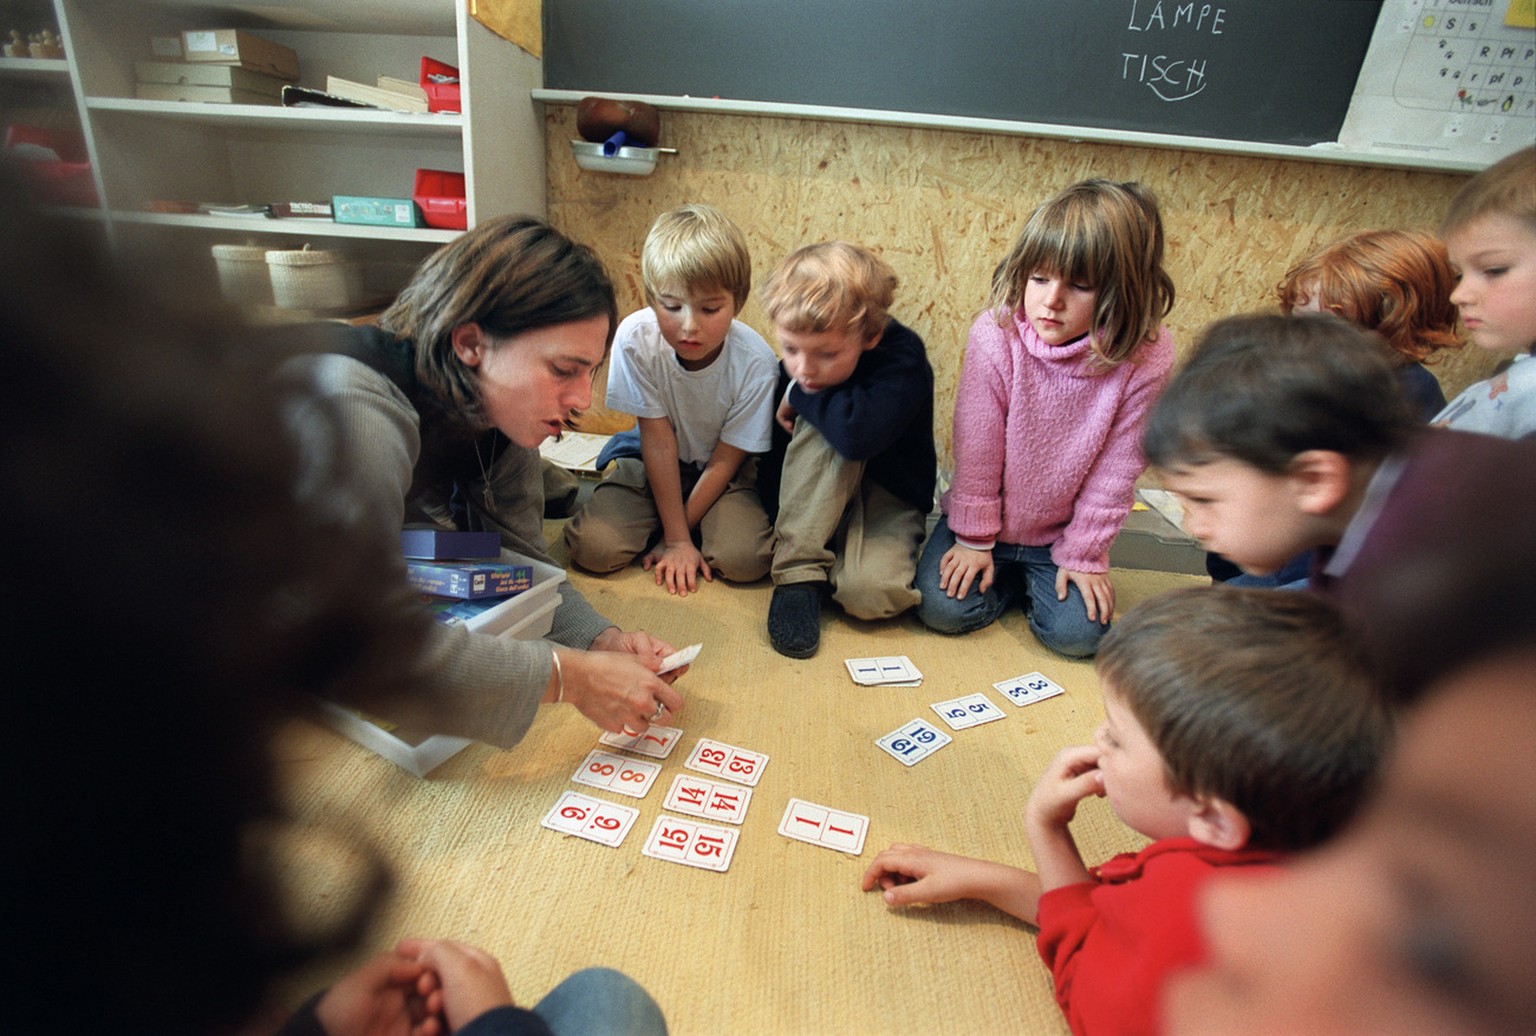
[1339, 0, 1536, 164]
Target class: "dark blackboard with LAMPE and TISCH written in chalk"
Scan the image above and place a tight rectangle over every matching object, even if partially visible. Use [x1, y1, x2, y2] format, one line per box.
[544, 0, 1381, 146]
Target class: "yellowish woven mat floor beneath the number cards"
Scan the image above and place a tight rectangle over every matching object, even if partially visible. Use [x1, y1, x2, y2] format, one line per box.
[280, 526, 1204, 1036]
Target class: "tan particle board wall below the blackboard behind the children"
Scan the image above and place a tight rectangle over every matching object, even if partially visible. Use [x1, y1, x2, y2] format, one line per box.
[545, 105, 1493, 467]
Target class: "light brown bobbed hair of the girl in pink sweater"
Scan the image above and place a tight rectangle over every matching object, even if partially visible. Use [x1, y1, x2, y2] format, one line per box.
[988, 180, 1174, 370]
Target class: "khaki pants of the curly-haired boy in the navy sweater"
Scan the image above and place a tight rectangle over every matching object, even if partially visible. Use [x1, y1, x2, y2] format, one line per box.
[773, 418, 926, 619]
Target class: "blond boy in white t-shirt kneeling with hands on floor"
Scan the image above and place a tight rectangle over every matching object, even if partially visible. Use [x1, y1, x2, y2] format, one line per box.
[565, 204, 779, 596]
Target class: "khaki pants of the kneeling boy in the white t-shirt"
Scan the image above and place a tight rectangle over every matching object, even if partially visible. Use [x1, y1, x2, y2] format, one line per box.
[565, 457, 773, 583]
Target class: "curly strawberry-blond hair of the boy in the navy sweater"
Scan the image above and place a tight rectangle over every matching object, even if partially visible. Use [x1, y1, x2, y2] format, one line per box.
[762, 241, 895, 341]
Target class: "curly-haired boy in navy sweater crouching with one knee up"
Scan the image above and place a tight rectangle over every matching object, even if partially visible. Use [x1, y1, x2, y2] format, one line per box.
[763, 241, 935, 658]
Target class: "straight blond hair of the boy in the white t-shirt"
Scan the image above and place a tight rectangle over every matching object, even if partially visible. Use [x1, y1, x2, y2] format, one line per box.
[641, 204, 753, 310]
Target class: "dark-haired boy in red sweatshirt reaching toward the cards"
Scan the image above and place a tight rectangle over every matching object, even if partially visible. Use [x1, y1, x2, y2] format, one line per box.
[862, 586, 1389, 1034]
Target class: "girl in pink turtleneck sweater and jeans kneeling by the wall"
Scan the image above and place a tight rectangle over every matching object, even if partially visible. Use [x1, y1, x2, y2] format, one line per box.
[917, 180, 1174, 658]
